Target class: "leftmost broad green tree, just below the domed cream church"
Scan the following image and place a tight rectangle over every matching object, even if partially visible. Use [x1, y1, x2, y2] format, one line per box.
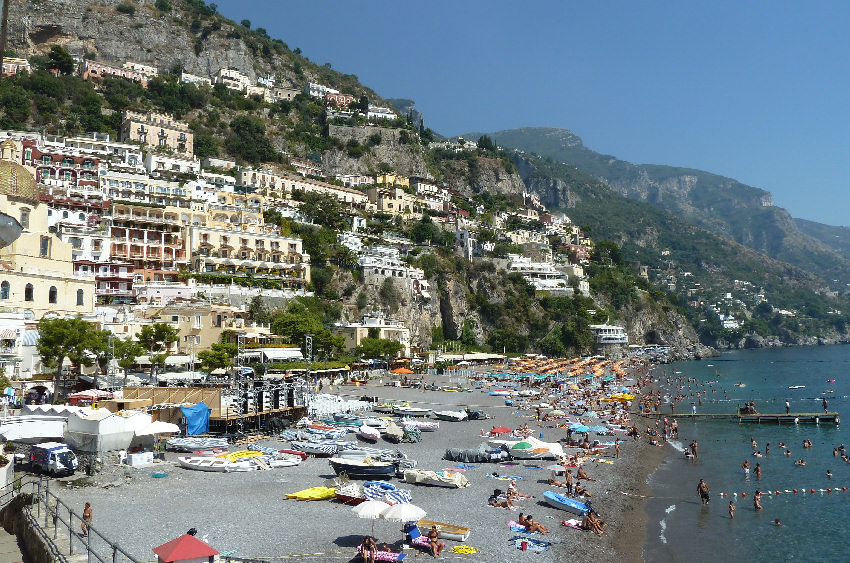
[38, 318, 94, 397]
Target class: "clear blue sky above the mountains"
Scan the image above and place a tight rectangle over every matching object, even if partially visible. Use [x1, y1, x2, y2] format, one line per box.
[217, 0, 850, 225]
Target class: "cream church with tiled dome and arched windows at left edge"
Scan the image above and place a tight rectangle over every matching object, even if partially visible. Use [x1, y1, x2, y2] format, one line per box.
[0, 156, 95, 320]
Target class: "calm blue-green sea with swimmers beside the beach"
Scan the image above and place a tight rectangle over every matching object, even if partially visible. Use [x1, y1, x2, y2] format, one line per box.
[640, 345, 850, 563]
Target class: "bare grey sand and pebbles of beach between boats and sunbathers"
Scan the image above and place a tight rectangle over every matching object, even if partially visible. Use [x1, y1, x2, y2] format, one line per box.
[53, 374, 663, 562]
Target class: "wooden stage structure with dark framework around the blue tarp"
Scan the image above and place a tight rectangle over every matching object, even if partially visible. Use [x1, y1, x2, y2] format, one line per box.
[124, 381, 307, 432]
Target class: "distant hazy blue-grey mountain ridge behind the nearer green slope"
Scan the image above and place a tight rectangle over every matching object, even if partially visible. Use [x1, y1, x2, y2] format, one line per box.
[463, 127, 850, 290]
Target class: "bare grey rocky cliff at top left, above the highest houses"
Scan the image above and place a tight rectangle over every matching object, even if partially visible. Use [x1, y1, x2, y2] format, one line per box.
[8, 0, 380, 97]
